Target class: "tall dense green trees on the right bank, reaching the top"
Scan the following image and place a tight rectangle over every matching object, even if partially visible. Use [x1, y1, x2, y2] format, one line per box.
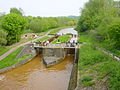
[76, 0, 120, 50]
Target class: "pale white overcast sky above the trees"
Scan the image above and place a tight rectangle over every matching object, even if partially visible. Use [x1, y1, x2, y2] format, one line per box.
[0, 0, 88, 17]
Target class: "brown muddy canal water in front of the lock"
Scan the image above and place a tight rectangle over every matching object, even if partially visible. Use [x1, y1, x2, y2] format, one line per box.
[0, 55, 73, 90]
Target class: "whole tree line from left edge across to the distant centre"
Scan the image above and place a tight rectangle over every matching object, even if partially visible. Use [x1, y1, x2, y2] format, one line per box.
[0, 8, 77, 45]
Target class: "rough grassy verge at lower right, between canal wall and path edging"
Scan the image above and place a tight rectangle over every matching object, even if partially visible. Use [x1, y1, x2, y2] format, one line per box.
[78, 45, 120, 90]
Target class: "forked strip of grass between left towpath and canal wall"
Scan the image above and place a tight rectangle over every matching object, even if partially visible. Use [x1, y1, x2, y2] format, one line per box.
[0, 47, 31, 69]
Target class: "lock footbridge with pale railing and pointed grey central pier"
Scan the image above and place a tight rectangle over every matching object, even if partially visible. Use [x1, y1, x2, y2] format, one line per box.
[34, 43, 80, 67]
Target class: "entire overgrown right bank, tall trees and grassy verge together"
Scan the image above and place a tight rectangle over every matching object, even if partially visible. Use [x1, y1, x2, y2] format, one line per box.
[76, 0, 120, 90]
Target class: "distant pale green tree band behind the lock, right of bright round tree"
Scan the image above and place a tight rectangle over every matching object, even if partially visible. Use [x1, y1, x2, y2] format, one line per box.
[26, 16, 77, 33]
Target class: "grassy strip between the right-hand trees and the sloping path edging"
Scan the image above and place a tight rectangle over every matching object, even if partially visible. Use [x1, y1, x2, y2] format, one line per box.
[79, 30, 120, 56]
